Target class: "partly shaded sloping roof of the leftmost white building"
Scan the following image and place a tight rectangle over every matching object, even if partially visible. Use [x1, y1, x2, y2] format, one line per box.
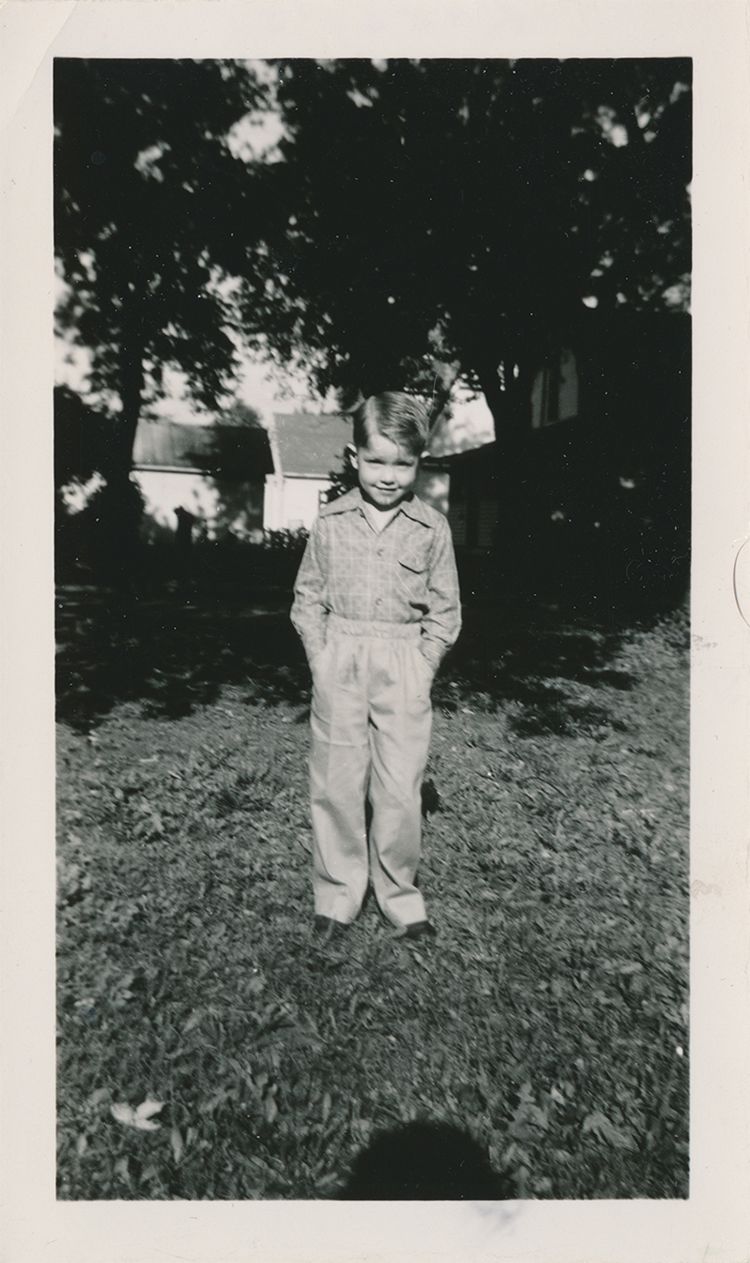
[133, 417, 273, 479]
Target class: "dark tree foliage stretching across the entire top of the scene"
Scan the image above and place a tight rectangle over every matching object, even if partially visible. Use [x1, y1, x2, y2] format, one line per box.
[56, 58, 691, 469]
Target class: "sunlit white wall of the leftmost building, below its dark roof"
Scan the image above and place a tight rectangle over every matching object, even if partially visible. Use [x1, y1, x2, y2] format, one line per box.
[133, 470, 263, 539]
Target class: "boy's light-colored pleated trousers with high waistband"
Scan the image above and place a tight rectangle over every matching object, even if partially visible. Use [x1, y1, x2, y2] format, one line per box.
[309, 614, 432, 926]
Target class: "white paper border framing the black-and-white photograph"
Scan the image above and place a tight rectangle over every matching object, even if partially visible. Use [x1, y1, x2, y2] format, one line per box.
[0, 0, 750, 1263]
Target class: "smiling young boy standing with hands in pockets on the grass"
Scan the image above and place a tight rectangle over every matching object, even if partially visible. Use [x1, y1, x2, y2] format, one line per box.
[292, 392, 461, 938]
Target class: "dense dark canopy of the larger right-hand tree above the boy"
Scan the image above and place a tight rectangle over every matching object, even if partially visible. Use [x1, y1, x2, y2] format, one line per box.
[237, 59, 691, 437]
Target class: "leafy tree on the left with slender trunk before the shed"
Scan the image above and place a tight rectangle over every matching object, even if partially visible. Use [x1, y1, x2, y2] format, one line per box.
[54, 58, 258, 485]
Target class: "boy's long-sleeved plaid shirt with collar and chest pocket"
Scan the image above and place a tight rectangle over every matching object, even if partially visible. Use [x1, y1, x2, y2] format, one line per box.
[292, 488, 461, 669]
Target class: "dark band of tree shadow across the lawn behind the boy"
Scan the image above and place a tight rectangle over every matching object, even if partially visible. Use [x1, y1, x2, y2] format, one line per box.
[57, 587, 681, 736]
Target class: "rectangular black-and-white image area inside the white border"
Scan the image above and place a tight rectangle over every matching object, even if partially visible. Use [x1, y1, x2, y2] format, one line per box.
[54, 57, 692, 1200]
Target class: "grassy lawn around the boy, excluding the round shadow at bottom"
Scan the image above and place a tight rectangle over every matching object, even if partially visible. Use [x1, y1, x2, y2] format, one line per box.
[58, 592, 688, 1199]
